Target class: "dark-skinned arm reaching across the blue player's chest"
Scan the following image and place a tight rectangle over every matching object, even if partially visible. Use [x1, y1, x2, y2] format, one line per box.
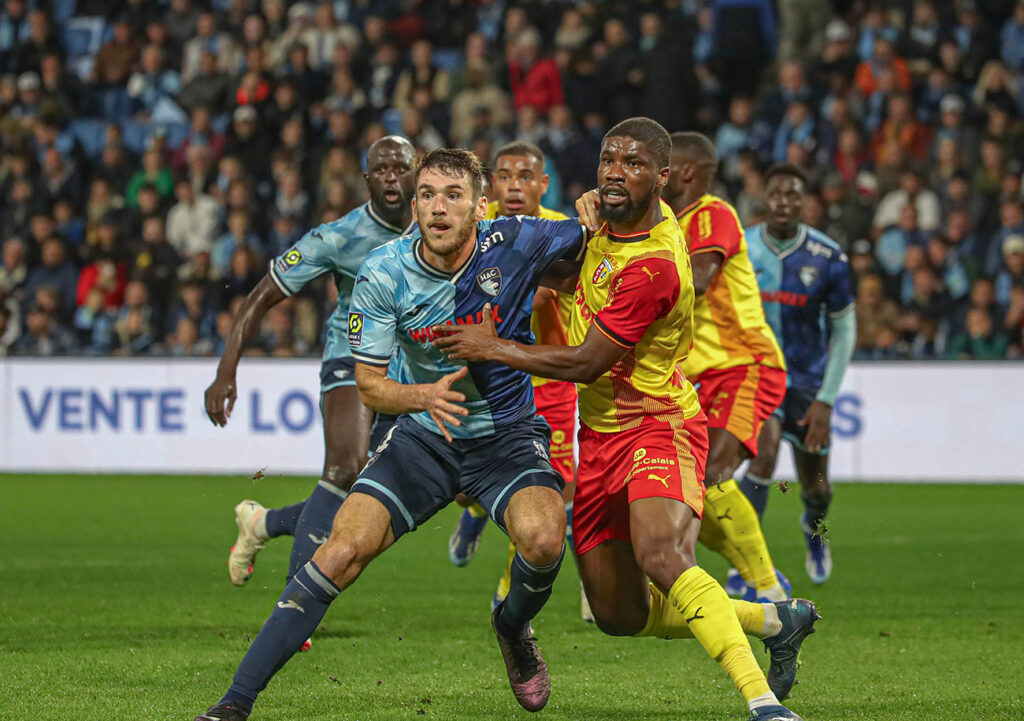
[432, 304, 629, 383]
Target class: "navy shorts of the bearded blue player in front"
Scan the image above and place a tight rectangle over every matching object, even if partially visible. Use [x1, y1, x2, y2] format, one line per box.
[349, 416, 564, 539]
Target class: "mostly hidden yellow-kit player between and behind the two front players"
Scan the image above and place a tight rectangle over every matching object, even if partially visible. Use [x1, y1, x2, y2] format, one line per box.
[449, 141, 594, 622]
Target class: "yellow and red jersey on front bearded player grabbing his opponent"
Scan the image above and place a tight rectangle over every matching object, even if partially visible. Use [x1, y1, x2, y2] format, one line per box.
[569, 211, 700, 433]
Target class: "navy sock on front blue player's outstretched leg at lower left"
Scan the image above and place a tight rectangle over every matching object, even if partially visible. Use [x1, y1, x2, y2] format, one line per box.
[220, 561, 340, 711]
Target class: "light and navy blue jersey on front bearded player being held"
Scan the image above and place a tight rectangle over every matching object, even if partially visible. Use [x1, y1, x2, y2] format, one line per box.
[348, 215, 585, 438]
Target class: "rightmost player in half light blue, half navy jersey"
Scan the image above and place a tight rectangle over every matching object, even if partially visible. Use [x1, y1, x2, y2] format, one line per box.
[740, 165, 857, 584]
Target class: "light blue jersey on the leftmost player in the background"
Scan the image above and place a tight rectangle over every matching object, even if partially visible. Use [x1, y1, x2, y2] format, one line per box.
[270, 203, 414, 362]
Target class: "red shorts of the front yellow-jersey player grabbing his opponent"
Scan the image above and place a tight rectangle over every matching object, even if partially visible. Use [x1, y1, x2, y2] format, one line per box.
[572, 413, 708, 555]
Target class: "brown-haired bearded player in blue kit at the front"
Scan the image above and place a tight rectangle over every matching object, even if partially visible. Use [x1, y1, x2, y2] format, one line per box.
[197, 150, 585, 721]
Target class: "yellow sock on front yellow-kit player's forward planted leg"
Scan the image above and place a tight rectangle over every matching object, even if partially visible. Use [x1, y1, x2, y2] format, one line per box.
[669, 566, 771, 702]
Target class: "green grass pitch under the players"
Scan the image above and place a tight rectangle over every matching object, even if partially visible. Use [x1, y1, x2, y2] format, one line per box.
[0, 475, 1024, 721]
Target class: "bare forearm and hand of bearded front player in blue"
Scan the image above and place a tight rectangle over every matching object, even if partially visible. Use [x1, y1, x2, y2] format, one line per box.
[355, 363, 469, 442]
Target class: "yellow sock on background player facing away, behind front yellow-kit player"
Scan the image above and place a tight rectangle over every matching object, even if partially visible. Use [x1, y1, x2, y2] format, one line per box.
[705, 479, 782, 589]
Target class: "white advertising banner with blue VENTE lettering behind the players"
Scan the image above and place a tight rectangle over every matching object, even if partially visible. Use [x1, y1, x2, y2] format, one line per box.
[0, 358, 1024, 482]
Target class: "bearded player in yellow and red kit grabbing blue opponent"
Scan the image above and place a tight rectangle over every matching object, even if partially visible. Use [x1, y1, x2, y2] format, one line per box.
[432, 118, 815, 721]
